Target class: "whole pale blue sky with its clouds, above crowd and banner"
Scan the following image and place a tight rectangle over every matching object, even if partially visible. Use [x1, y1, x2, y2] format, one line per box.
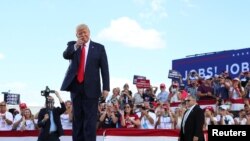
[0, 0, 250, 105]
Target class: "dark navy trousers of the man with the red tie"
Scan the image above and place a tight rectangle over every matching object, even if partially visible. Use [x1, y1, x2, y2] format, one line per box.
[71, 79, 98, 141]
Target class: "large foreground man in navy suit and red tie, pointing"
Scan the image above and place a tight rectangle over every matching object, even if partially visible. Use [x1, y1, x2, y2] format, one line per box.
[61, 24, 110, 141]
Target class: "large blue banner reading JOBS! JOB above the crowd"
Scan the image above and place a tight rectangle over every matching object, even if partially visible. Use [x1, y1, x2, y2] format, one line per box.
[172, 48, 250, 81]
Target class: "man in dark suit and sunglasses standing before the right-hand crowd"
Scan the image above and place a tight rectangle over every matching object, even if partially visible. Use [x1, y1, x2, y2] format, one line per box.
[178, 95, 205, 141]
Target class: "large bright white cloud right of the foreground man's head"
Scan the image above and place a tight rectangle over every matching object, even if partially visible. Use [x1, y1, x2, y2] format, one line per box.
[97, 17, 165, 49]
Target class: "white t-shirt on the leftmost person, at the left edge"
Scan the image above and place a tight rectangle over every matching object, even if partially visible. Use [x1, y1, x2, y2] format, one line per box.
[0, 111, 13, 131]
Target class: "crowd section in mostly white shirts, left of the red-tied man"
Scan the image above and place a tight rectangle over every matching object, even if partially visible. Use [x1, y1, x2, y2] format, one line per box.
[0, 101, 73, 131]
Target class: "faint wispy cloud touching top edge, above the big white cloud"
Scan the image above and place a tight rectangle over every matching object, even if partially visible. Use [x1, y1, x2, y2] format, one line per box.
[135, 0, 168, 21]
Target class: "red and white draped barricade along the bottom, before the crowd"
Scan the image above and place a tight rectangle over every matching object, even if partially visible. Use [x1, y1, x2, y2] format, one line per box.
[0, 128, 207, 141]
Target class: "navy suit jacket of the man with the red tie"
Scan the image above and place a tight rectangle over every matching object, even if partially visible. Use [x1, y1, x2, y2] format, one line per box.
[61, 41, 110, 98]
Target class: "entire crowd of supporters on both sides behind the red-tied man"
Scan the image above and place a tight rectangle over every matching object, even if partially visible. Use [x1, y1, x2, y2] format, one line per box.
[0, 71, 250, 131]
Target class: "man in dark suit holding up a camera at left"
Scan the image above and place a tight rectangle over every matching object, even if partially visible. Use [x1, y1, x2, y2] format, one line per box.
[38, 91, 66, 141]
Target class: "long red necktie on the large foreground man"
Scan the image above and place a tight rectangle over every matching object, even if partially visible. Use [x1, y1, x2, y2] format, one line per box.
[77, 45, 85, 83]
